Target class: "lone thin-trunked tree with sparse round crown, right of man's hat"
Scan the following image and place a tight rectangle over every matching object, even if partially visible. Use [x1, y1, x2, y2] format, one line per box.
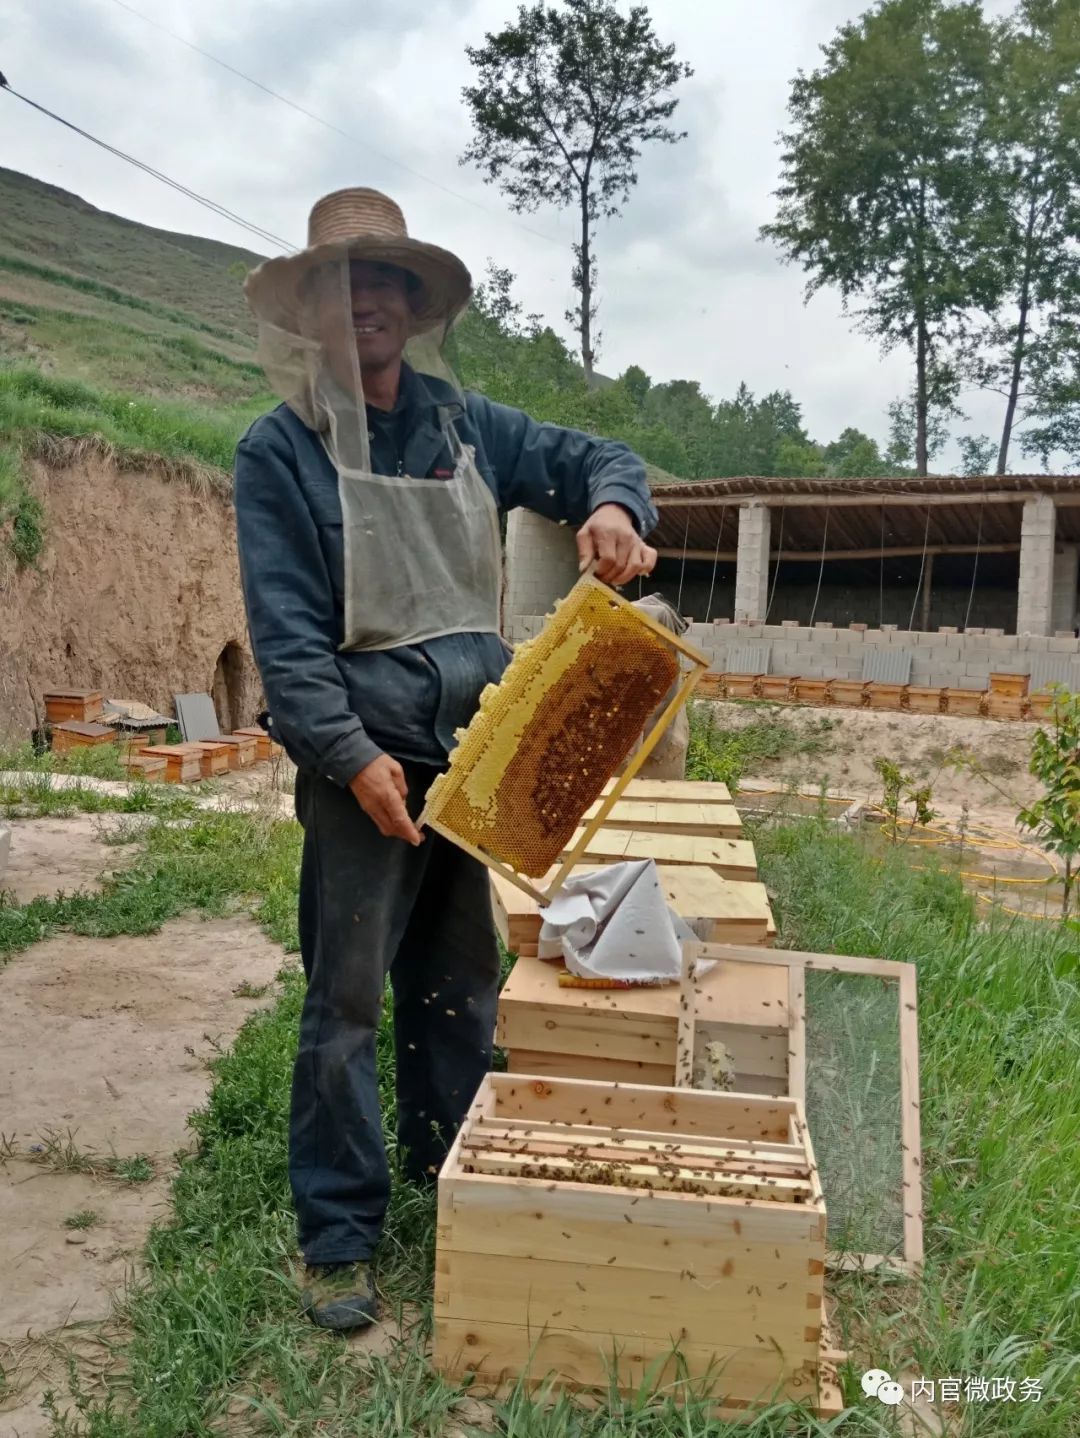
[460, 0, 693, 384]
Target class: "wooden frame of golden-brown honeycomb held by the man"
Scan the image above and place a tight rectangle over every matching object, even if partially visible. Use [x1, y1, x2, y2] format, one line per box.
[418, 574, 708, 903]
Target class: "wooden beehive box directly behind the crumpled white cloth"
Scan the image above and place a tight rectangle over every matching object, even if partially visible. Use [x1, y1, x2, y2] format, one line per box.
[492, 864, 777, 958]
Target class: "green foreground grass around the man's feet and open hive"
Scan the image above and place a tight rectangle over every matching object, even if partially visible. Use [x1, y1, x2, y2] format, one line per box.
[0, 815, 1080, 1438]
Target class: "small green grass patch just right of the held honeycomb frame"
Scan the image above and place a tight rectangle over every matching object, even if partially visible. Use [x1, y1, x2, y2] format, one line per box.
[686, 702, 836, 789]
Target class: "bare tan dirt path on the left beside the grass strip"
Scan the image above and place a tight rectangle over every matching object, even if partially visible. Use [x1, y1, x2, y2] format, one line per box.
[0, 817, 282, 1438]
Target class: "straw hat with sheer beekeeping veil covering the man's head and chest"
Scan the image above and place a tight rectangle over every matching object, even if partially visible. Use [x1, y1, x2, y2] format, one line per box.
[244, 188, 500, 649]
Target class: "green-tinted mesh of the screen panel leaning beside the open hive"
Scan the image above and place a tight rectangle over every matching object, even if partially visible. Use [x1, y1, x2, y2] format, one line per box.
[805, 969, 903, 1255]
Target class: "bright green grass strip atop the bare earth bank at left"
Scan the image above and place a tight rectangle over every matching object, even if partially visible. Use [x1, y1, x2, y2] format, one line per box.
[0, 368, 261, 485]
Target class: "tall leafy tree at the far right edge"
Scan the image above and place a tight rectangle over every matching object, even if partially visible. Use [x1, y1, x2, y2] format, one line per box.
[968, 0, 1080, 475]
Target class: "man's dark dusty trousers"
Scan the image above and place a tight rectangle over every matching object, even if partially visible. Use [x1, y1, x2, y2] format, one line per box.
[289, 764, 499, 1264]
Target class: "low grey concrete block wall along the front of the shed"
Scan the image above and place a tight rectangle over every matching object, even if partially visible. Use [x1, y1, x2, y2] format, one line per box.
[509, 615, 1080, 692]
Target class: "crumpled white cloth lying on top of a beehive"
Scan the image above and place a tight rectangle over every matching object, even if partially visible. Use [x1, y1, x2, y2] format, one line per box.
[536, 858, 695, 984]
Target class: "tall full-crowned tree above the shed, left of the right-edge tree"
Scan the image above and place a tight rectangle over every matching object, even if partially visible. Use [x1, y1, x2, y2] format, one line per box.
[762, 0, 999, 475]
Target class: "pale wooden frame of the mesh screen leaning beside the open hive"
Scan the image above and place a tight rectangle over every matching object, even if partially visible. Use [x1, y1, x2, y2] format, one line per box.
[676, 943, 923, 1276]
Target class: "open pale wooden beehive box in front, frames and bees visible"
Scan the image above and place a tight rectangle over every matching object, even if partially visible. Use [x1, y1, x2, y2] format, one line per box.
[434, 1074, 841, 1414]
